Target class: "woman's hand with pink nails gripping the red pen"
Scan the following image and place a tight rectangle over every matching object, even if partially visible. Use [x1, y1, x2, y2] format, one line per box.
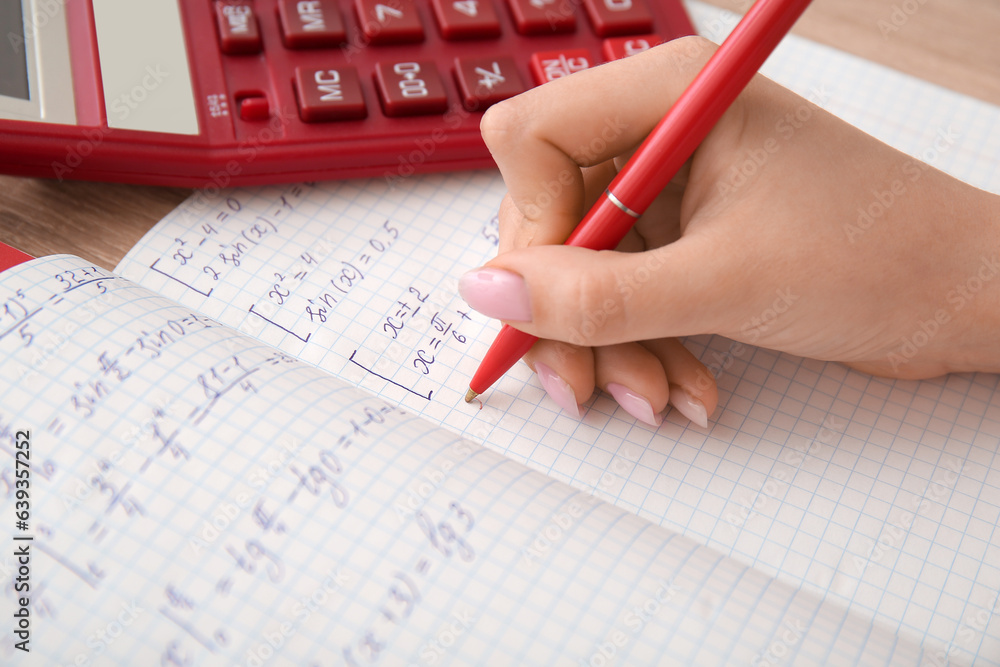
[460, 37, 1000, 426]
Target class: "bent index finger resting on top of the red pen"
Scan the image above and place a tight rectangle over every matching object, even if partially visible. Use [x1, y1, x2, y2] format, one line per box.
[481, 37, 714, 237]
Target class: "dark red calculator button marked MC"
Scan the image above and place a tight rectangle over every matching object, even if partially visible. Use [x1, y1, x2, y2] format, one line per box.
[295, 67, 368, 123]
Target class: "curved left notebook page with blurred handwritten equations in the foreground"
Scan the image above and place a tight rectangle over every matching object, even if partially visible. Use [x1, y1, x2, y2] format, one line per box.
[0, 256, 920, 667]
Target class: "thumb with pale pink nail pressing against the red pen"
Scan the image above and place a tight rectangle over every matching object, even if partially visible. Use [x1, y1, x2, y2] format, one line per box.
[458, 237, 726, 346]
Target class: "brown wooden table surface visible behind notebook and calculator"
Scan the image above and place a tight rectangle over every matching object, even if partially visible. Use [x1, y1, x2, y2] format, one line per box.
[0, 0, 1000, 269]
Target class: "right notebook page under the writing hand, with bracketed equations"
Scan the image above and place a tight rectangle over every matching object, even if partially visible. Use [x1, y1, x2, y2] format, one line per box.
[111, 5, 1000, 661]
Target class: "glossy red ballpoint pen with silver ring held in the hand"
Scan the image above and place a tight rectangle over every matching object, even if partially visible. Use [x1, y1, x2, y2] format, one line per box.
[465, 0, 810, 403]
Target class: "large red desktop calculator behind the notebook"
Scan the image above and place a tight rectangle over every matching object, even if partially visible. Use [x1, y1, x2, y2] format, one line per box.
[0, 0, 693, 188]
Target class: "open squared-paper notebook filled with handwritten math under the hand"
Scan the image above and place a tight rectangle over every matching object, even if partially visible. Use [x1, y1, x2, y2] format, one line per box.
[0, 4, 1000, 665]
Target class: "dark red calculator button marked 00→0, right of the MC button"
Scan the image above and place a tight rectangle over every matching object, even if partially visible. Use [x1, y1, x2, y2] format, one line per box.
[375, 61, 448, 116]
